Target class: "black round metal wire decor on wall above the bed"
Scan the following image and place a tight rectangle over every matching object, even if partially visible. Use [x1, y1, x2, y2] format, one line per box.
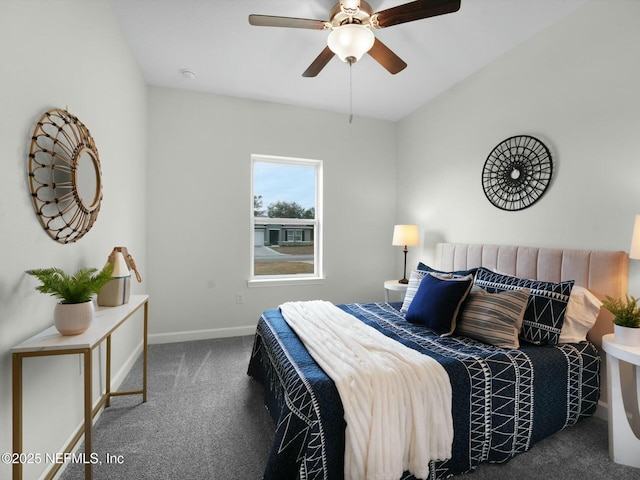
[482, 135, 553, 211]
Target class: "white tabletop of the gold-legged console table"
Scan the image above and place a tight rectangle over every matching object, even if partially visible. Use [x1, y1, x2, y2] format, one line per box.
[11, 295, 149, 353]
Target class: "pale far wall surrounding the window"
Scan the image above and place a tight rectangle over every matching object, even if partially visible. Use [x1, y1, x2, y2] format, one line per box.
[148, 87, 401, 342]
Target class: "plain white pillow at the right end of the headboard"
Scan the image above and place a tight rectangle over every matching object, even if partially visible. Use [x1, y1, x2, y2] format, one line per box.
[558, 285, 602, 343]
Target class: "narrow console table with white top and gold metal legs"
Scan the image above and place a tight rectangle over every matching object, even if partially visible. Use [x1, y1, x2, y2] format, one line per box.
[11, 295, 149, 480]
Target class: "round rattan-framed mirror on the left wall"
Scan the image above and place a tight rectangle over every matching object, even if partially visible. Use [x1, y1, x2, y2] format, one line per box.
[29, 109, 102, 243]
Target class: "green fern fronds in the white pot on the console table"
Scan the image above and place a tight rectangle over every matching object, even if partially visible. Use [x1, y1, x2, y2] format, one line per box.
[26, 263, 113, 303]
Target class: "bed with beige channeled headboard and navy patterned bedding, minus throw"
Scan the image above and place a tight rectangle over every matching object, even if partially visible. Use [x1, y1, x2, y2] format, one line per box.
[248, 243, 628, 480]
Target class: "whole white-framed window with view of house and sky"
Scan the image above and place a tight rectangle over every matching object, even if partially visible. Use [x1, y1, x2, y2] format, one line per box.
[249, 155, 322, 285]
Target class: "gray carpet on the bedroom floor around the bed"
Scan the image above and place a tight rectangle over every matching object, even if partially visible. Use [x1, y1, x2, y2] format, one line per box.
[61, 337, 640, 480]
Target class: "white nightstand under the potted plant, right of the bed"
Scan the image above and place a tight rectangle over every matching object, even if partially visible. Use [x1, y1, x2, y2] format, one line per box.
[602, 333, 640, 467]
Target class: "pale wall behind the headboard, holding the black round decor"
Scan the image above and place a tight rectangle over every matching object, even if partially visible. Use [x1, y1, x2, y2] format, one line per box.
[397, 1, 640, 295]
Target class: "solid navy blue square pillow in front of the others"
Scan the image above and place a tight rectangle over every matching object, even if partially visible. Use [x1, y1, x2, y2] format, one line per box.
[405, 275, 473, 335]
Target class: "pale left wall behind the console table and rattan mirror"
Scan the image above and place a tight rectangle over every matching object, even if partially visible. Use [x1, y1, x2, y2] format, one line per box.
[0, 0, 147, 479]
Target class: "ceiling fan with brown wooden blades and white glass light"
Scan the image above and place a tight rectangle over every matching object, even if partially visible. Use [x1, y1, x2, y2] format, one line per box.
[249, 0, 460, 77]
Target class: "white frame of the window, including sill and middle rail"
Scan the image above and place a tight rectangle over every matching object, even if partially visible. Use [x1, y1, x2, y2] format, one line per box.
[247, 154, 324, 287]
